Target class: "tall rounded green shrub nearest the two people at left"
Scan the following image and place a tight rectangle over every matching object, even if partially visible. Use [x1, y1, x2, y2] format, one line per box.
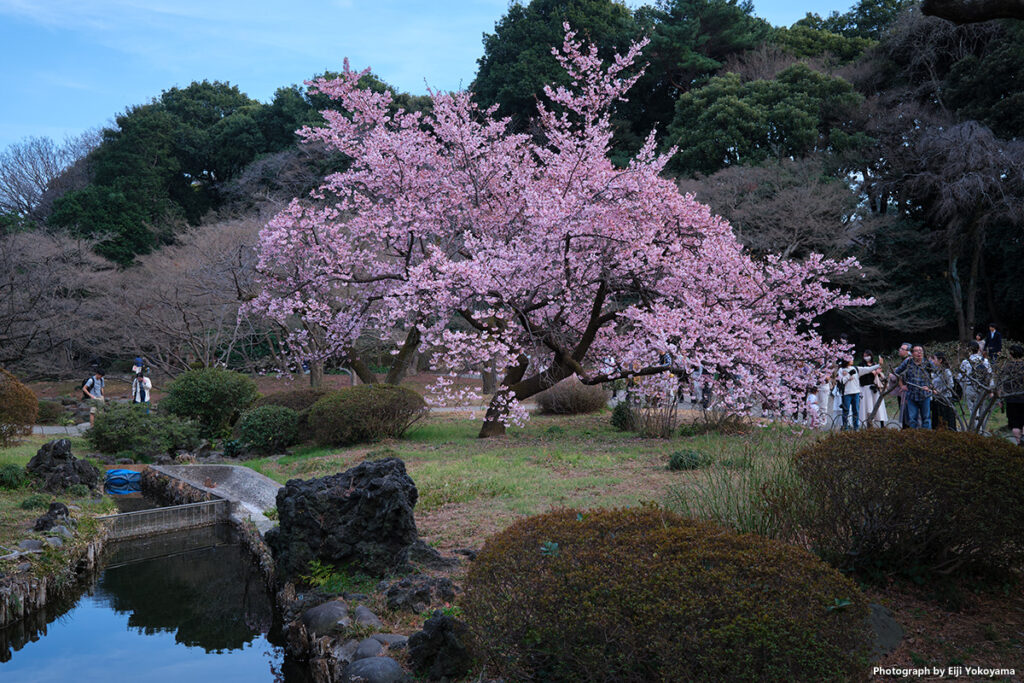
[160, 368, 258, 438]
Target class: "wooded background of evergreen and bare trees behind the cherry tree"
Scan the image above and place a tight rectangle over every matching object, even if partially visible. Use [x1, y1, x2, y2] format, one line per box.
[0, 0, 1024, 376]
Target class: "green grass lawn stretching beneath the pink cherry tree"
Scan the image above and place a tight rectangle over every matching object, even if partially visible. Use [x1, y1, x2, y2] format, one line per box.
[246, 413, 811, 549]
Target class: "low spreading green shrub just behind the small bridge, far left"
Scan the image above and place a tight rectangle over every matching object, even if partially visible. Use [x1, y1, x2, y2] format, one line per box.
[85, 403, 199, 460]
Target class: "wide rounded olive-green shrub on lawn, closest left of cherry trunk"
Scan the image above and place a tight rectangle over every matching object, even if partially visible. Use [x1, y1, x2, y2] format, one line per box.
[309, 384, 427, 445]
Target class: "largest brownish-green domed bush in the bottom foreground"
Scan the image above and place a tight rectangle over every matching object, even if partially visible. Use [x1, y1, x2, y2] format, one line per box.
[461, 507, 870, 682]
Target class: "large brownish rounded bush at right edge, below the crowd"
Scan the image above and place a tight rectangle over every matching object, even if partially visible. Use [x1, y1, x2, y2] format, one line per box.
[795, 429, 1024, 577]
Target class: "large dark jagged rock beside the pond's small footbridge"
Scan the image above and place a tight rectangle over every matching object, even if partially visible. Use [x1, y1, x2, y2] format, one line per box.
[266, 458, 419, 577]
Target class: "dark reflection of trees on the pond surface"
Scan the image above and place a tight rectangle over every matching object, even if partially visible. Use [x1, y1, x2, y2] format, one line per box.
[96, 546, 272, 652]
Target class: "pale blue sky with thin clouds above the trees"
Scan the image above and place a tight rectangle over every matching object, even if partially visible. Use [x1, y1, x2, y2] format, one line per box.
[0, 0, 852, 148]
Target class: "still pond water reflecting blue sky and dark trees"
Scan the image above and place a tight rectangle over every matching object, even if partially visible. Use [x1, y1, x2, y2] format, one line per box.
[0, 527, 306, 683]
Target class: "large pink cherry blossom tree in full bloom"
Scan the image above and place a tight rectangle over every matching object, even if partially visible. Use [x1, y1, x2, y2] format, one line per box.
[245, 26, 869, 437]
